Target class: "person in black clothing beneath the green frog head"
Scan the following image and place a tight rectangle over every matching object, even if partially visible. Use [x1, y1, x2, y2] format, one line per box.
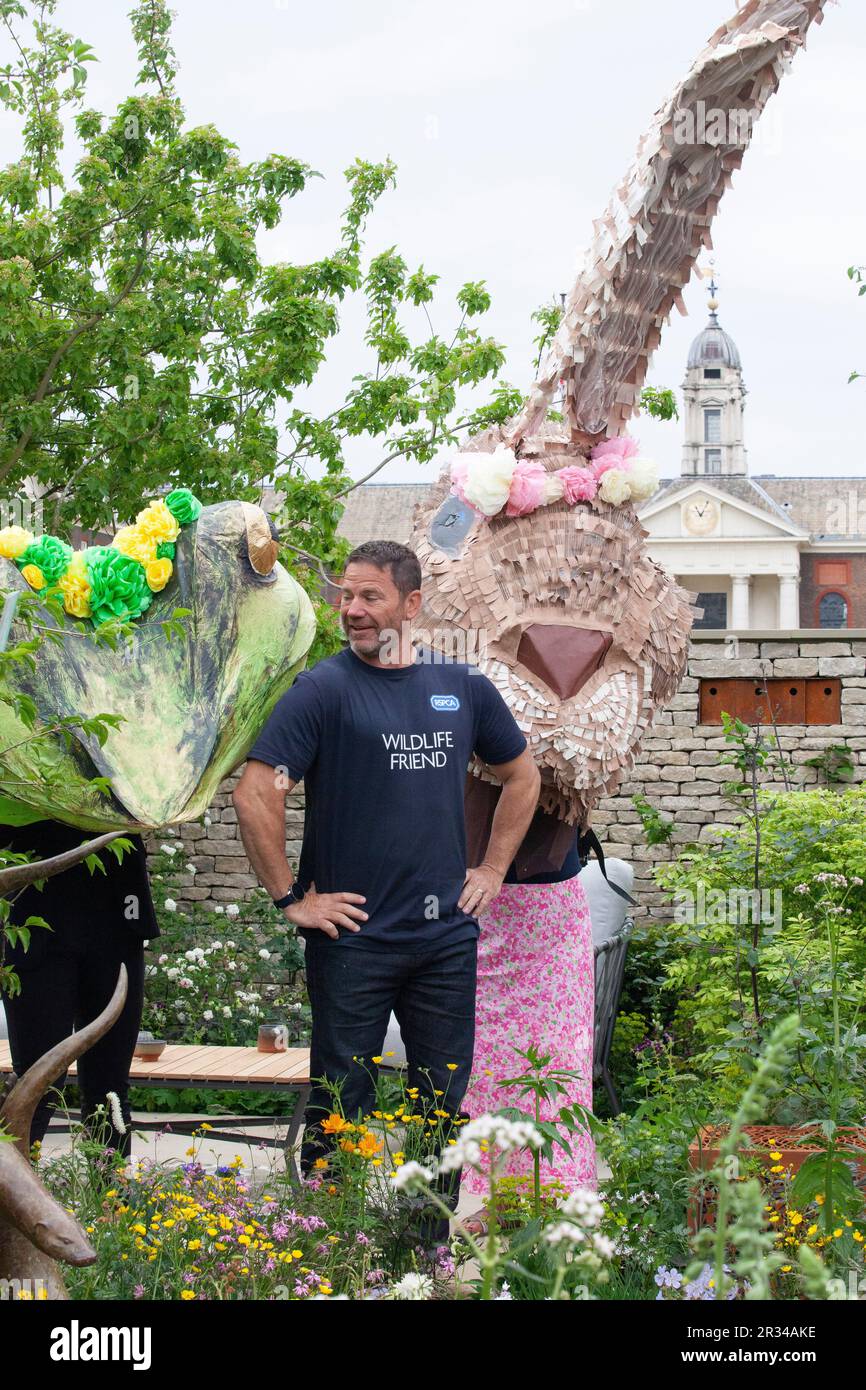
[0, 820, 160, 1155]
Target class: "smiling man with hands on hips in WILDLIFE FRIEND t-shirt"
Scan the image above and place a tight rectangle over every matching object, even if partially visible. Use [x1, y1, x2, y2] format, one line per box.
[234, 541, 539, 1234]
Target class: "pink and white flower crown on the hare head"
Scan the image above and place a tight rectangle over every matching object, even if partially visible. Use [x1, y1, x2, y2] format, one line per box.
[450, 435, 659, 517]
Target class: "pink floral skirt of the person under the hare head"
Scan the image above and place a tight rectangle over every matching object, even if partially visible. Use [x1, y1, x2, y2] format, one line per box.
[463, 874, 596, 1195]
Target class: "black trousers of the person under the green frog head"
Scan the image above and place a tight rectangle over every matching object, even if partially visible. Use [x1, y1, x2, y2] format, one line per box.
[4, 927, 145, 1156]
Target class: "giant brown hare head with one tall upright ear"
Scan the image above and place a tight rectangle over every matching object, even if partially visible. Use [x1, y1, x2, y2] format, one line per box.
[413, 0, 826, 877]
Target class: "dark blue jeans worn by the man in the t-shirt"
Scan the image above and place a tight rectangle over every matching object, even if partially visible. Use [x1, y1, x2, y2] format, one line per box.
[300, 934, 478, 1241]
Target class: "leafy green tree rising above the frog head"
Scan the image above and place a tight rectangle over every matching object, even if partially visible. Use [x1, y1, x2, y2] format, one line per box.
[0, 0, 520, 567]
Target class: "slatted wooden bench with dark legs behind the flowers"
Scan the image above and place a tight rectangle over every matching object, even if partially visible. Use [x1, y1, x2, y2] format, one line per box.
[0, 1041, 310, 1182]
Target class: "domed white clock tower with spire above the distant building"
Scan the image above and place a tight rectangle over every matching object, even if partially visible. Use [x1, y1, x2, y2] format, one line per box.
[683, 279, 748, 480]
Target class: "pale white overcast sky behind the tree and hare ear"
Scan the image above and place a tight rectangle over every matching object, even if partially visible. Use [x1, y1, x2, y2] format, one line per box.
[0, 0, 866, 482]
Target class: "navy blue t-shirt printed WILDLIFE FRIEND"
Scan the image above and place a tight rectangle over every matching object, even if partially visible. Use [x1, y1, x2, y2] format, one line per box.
[249, 648, 527, 948]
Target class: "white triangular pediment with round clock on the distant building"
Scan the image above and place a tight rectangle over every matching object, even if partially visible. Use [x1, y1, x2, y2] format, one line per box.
[639, 477, 808, 541]
